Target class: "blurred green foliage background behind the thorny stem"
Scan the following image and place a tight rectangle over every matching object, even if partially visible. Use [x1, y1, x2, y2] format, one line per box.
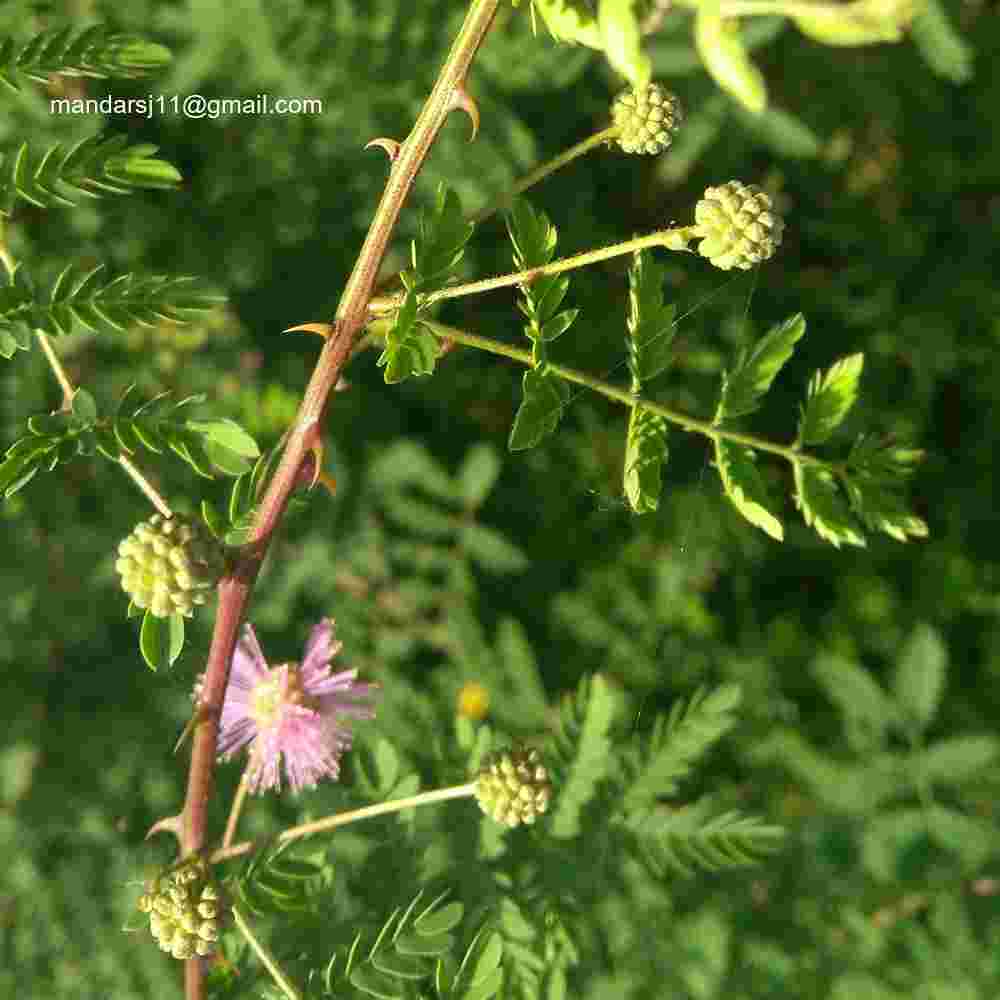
[0, 0, 1000, 1000]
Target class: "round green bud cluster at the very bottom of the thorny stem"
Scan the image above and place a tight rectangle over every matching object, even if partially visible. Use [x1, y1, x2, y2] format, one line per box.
[138, 858, 219, 960]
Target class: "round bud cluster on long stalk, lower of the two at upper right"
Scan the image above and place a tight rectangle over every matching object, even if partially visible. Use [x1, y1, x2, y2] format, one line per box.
[694, 181, 785, 271]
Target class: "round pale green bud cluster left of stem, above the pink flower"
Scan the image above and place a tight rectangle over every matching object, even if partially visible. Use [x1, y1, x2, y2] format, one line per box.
[115, 514, 224, 618]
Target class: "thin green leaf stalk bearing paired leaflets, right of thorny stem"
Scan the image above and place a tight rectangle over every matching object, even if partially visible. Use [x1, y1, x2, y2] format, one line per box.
[421, 320, 836, 469]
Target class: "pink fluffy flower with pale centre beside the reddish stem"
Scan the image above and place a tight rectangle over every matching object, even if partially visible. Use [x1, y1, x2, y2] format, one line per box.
[211, 618, 378, 792]
